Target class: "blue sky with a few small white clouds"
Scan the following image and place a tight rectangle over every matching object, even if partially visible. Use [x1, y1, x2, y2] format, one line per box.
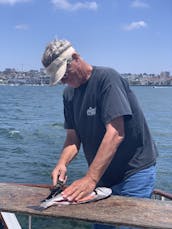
[0, 0, 172, 74]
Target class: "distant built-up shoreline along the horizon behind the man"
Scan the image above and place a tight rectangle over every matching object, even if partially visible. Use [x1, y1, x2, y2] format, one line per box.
[0, 68, 172, 87]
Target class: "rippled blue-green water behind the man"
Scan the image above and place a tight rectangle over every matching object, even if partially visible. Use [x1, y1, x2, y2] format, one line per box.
[0, 86, 172, 229]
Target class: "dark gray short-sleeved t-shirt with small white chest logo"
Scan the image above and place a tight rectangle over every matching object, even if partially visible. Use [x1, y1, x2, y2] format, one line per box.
[63, 66, 157, 187]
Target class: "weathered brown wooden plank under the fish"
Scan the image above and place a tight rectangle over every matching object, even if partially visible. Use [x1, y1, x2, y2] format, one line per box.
[0, 183, 172, 229]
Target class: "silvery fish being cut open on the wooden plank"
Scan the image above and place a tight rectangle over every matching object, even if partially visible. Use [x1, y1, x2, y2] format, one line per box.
[40, 187, 112, 209]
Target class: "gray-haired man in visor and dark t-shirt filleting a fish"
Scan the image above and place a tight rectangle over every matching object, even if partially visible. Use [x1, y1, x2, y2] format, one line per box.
[42, 40, 157, 227]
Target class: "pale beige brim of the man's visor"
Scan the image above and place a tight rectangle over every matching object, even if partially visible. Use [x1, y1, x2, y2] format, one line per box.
[50, 61, 67, 86]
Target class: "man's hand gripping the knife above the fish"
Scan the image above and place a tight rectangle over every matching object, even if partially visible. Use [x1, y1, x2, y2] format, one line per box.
[51, 164, 67, 186]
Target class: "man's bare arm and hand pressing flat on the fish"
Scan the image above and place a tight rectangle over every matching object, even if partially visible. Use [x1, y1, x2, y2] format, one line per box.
[63, 116, 125, 201]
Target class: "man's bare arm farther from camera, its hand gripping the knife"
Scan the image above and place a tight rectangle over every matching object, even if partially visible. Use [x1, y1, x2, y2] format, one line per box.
[51, 129, 80, 185]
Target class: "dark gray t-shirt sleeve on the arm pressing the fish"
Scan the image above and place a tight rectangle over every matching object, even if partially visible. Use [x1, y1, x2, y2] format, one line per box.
[99, 72, 132, 124]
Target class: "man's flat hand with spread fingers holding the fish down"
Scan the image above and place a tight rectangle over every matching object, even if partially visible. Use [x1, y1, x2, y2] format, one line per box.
[62, 176, 96, 201]
